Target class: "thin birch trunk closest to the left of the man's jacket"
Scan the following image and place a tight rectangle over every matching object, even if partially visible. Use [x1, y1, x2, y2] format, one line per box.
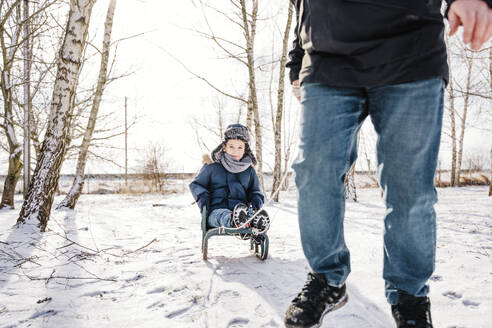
[271, 2, 293, 202]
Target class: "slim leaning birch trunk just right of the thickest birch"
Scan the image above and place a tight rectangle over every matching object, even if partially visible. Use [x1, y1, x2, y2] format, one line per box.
[57, 0, 116, 209]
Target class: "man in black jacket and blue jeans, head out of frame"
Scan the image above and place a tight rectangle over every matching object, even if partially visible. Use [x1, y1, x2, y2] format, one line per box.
[285, 0, 492, 328]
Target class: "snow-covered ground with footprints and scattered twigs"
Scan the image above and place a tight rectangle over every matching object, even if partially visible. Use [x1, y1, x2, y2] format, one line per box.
[0, 187, 492, 328]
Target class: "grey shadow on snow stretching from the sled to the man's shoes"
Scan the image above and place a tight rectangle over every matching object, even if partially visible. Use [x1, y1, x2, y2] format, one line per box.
[208, 256, 394, 328]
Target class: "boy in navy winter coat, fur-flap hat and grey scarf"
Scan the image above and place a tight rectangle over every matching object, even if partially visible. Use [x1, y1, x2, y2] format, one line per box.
[190, 124, 270, 242]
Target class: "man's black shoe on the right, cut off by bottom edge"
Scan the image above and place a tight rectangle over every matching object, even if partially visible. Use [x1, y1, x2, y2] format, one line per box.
[391, 293, 433, 328]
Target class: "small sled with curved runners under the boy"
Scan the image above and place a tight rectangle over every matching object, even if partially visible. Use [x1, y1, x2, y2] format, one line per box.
[202, 207, 269, 261]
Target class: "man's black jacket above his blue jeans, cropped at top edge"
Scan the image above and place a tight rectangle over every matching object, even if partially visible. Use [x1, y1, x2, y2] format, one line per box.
[287, 0, 492, 88]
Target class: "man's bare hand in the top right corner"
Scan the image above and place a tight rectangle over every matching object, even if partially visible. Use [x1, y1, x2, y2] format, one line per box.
[448, 0, 492, 50]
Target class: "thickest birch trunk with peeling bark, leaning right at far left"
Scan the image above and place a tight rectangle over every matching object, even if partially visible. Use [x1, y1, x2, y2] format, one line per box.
[17, 0, 95, 232]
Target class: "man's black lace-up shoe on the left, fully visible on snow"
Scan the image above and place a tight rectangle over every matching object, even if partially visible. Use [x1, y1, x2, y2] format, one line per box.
[284, 272, 348, 328]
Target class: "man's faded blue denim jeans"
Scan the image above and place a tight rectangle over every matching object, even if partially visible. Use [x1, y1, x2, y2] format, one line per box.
[293, 78, 444, 304]
